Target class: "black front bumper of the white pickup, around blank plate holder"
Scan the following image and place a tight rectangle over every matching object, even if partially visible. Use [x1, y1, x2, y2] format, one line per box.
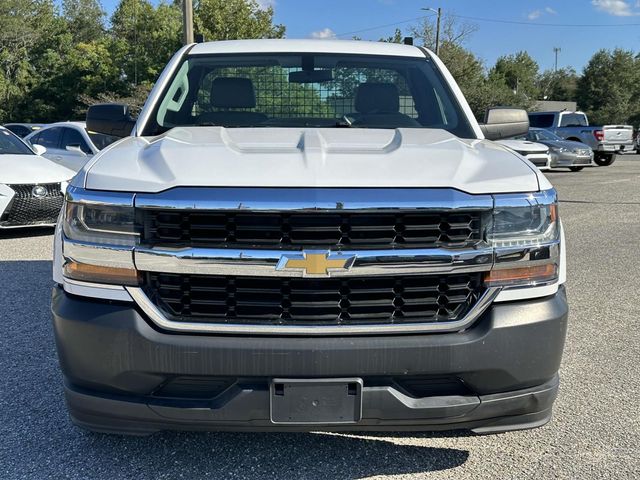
[52, 287, 567, 434]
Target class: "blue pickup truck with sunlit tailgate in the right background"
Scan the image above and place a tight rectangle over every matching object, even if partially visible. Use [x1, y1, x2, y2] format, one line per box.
[529, 111, 633, 166]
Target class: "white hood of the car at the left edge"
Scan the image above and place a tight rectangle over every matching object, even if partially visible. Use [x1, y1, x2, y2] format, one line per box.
[0, 155, 75, 185]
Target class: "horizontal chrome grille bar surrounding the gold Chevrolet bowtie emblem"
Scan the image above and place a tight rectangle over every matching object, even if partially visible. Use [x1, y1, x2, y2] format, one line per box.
[133, 247, 494, 277]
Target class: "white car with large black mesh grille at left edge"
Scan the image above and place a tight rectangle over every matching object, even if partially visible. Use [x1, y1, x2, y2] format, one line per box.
[0, 127, 74, 230]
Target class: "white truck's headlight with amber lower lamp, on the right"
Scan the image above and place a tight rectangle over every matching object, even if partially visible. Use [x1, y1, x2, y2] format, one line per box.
[485, 189, 560, 287]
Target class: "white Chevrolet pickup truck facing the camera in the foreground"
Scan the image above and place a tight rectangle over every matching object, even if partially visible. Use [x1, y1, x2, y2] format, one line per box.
[52, 40, 568, 434]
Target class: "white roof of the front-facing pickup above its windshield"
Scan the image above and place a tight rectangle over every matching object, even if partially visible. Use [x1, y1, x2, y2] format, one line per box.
[189, 39, 425, 58]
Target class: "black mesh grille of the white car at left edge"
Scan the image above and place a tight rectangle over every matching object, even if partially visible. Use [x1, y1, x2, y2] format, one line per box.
[0, 183, 64, 226]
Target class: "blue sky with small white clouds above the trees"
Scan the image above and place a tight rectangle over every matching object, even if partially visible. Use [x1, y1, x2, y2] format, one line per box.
[102, 0, 640, 71]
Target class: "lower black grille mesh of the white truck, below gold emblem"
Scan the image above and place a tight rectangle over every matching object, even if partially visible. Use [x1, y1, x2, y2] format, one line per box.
[145, 273, 482, 325]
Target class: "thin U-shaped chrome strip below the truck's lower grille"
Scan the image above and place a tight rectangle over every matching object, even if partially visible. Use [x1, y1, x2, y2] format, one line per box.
[125, 287, 501, 336]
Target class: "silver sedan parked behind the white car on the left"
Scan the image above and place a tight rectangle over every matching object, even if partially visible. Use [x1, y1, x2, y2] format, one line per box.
[25, 122, 118, 172]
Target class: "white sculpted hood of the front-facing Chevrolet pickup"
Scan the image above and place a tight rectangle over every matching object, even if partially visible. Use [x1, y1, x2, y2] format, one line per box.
[84, 127, 546, 193]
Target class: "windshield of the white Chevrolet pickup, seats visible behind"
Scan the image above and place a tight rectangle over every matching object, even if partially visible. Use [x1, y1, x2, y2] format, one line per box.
[143, 54, 475, 138]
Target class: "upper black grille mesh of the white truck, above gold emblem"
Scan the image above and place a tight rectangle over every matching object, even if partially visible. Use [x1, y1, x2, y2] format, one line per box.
[144, 210, 481, 249]
